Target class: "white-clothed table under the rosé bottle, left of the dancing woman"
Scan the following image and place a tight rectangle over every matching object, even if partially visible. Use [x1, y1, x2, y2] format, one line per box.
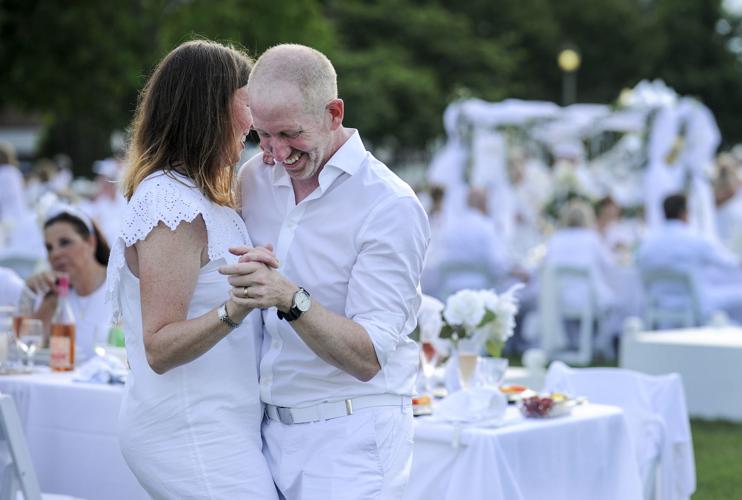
[0, 373, 149, 500]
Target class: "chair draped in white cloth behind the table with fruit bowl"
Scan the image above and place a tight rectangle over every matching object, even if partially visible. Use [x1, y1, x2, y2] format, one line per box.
[544, 361, 695, 500]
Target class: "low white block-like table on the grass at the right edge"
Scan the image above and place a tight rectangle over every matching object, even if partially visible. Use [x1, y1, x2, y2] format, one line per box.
[620, 328, 742, 422]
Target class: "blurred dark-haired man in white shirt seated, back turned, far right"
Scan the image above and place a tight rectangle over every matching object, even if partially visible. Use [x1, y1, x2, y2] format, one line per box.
[637, 194, 742, 321]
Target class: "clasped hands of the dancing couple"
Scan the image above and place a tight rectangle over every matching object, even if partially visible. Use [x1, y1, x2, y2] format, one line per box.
[219, 245, 298, 312]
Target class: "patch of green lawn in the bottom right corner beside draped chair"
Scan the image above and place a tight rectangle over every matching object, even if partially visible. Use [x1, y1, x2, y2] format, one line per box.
[691, 420, 742, 500]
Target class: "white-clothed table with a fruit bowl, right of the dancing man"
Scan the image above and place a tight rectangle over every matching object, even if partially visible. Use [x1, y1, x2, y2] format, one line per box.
[407, 405, 642, 500]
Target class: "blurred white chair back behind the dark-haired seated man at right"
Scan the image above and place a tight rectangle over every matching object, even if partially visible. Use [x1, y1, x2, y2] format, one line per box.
[641, 267, 703, 330]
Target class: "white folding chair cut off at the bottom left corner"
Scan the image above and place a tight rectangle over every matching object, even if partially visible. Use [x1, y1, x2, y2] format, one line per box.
[0, 394, 79, 500]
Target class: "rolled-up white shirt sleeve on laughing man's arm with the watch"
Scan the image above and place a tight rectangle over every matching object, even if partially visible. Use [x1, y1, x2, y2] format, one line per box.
[345, 195, 430, 368]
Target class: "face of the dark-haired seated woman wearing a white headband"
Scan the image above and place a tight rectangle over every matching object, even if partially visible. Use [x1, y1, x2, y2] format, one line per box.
[44, 221, 96, 283]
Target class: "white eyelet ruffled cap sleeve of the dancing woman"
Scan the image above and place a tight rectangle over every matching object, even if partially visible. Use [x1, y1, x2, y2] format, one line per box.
[107, 173, 250, 318]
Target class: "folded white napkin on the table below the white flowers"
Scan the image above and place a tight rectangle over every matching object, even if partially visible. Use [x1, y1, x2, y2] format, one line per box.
[434, 387, 508, 422]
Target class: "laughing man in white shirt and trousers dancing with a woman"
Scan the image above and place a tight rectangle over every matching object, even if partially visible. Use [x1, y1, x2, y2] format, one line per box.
[222, 45, 430, 500]
